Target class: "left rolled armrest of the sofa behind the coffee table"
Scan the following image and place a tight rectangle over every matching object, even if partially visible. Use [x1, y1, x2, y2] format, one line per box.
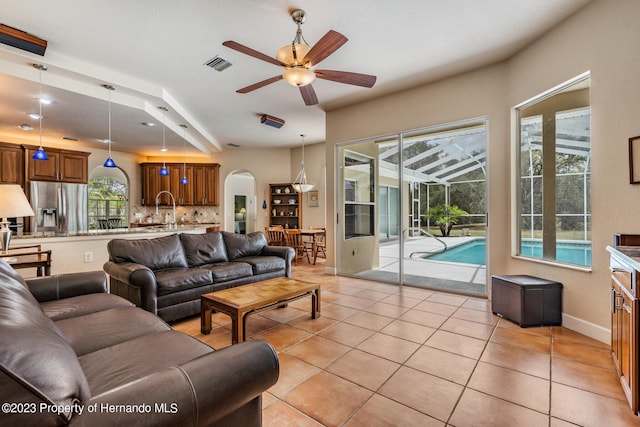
[102, 261, 158, 314]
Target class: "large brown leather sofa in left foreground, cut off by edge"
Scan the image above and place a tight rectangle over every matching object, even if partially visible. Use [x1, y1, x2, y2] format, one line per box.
[0, 260, 279, 427]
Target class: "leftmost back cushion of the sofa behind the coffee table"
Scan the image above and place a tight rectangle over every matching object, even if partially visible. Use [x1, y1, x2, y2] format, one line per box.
[107, 234, 187, 270]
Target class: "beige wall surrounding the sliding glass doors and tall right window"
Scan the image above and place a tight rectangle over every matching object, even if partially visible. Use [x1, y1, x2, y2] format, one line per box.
[326, 0, 640, 342]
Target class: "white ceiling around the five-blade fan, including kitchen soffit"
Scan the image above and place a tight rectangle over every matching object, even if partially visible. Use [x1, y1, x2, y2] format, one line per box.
[0, 0, 590, 156]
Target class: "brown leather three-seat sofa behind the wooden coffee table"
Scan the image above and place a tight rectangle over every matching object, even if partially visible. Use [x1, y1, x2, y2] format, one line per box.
[104, 231, 295, 322]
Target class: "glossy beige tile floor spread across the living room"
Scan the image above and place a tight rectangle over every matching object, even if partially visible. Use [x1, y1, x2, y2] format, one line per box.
[174, 261, 640, 427]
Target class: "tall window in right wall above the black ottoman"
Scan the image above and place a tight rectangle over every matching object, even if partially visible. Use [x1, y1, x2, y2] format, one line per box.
[516, 75, 591, 266]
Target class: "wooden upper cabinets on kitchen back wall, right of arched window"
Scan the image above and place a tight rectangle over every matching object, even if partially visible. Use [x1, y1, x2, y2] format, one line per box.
[141, 163, 220, 206]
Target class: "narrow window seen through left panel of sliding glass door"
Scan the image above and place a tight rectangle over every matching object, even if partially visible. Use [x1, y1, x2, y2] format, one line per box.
[344, 150, 375, 239]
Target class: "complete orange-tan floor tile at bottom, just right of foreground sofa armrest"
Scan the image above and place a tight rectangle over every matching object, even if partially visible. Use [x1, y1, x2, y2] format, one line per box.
[284, 372, 373, 426]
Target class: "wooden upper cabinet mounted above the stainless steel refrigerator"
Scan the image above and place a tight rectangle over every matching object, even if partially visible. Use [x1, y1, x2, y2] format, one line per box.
[24, 146, 91, 184]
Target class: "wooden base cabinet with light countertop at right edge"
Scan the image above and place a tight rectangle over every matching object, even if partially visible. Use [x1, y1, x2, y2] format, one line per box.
[607, 246, 640, 414]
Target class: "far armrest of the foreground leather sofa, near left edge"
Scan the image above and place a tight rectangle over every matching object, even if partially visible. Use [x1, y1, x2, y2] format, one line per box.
[25, 271, 107, 302]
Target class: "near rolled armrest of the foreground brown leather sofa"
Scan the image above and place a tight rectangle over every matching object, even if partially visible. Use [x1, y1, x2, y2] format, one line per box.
[70, 340, 279, 427]
